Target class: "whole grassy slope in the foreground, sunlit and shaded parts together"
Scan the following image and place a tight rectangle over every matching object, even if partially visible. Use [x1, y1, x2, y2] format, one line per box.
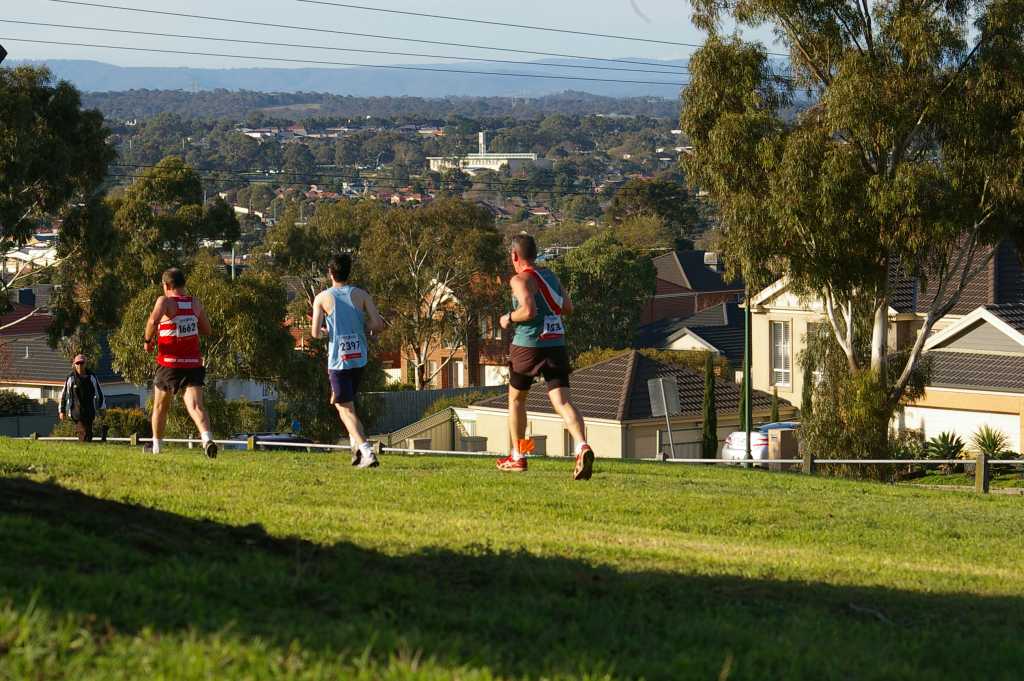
[0, 439, 1024, 681]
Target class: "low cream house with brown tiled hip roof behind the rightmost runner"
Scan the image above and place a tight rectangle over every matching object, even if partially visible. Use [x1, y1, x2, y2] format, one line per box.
[459, 350, 796, 459]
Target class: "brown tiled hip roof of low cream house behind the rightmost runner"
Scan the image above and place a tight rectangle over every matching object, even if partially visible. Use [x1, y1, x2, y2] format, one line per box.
[477, 350, 774, 421]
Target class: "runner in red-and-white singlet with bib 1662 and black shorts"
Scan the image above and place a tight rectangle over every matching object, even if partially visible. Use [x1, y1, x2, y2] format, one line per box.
[145, 267, 217, 459]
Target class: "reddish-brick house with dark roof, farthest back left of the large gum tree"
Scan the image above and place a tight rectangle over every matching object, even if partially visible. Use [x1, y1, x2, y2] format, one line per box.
[640, 251, 743, 325]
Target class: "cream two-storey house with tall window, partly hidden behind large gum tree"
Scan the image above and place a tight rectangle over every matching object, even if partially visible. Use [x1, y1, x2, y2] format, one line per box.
[751, 243, 1024, 406]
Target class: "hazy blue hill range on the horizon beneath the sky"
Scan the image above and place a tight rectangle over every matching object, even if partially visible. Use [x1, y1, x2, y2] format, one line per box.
[12, 59, 685, 99]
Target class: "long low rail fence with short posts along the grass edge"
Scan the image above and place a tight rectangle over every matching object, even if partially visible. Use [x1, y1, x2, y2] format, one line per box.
[15, 434, 1024, 494]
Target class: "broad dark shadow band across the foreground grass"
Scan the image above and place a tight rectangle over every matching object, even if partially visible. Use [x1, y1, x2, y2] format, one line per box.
[0, 478, 1024, 679]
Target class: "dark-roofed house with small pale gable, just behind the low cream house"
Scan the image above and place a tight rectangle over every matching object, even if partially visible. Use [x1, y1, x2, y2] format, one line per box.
[633, 302, 743, 366]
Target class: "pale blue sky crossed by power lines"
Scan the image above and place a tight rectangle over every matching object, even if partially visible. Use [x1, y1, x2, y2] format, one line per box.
[0, 0, 774, 68]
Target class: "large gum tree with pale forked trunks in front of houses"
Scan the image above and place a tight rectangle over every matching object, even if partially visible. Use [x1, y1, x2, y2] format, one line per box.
[681, 0, 1024, 440]
